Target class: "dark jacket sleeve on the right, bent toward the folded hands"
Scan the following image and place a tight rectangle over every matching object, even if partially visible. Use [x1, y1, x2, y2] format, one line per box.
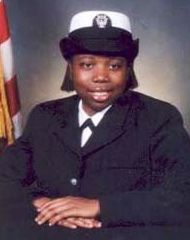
[100, 107, 190, 226]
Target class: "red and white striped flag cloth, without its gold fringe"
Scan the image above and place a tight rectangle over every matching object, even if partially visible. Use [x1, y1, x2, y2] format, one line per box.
[0, 0, 21, 144]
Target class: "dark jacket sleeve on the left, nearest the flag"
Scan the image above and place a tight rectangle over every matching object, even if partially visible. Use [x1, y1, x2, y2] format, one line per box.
[0, 106, 63, 240]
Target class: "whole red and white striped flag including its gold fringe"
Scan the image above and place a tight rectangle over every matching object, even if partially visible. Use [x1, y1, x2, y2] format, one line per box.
[0, 0, 22, 149]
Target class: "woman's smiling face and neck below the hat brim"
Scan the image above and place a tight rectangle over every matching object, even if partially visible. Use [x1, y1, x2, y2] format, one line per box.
[70, 54, 128, 115]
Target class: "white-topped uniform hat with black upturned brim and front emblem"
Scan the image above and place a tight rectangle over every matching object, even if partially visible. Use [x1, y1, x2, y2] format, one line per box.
[60, 11, 138, 60]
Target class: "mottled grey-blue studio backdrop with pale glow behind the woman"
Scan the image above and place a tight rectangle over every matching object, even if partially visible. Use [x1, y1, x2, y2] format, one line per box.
[5, 0, 190, 132]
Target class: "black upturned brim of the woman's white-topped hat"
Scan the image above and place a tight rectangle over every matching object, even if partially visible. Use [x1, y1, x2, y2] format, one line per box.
[60, 28, 139, 60]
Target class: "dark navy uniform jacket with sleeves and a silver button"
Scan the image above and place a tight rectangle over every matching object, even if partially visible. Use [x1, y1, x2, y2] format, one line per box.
[0, 91, 190, 240]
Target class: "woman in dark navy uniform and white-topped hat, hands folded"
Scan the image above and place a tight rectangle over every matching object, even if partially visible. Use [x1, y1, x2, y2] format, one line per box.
[0, 11, 190, 240]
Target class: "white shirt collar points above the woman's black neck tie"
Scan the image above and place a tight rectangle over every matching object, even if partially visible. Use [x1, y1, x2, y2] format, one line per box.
[78, 100, 112, 126]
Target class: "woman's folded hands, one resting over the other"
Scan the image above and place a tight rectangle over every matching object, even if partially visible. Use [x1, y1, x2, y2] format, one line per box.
[33, 197, 101, 228]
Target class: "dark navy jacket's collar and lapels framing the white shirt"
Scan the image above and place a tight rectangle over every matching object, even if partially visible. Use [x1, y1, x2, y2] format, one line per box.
[54, 92, 137, 156]
